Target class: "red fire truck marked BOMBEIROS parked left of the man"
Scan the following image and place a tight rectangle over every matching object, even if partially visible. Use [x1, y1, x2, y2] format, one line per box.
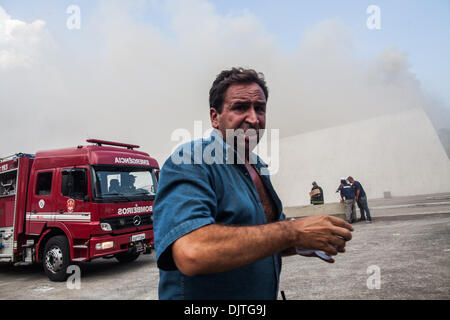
[0, 139, 159, 281]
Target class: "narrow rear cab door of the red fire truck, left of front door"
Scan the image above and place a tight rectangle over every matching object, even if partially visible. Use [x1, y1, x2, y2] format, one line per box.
[27, 169, 56, 234]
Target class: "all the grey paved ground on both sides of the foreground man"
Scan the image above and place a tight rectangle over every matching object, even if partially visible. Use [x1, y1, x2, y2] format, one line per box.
[0, 194, 450, 300]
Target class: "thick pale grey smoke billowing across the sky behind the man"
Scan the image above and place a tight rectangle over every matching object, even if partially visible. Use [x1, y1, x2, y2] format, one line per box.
[0, 0, 446, 163]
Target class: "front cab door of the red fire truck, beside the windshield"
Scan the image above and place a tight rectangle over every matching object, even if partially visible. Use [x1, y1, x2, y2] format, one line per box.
[55, 167, 91, 223]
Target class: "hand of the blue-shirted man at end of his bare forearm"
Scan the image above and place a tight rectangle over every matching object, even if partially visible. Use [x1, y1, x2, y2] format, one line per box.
[292, 215, 353, 256]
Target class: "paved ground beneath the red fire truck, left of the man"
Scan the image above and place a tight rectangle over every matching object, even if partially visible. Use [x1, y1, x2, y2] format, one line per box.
[0, 253, 159, 300]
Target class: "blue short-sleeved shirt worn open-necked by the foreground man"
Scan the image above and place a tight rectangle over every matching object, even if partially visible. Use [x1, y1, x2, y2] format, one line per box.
[154, 131, 285, 300]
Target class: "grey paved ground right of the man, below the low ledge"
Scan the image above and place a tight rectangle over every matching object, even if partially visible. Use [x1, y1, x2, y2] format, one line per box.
[280, 214, 450, 300]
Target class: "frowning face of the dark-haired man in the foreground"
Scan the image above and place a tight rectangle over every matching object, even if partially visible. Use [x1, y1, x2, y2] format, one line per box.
[210, 83, 267, 152]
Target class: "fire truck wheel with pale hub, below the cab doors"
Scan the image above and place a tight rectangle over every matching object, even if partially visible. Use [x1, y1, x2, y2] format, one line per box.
[43, 236, 70, 282]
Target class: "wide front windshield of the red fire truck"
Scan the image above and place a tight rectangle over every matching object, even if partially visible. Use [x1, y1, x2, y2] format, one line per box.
[93, 166, 157, 202]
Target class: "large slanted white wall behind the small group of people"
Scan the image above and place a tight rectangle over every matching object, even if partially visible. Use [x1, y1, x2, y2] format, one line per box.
[272, 109, 450, 207]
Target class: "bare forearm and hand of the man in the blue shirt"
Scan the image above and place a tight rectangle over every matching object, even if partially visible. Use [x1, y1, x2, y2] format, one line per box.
[171, 216, 353, 276]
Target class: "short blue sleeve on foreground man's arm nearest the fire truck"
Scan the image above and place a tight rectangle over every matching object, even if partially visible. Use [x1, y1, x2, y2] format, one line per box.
[153, 154, 217, 271]
